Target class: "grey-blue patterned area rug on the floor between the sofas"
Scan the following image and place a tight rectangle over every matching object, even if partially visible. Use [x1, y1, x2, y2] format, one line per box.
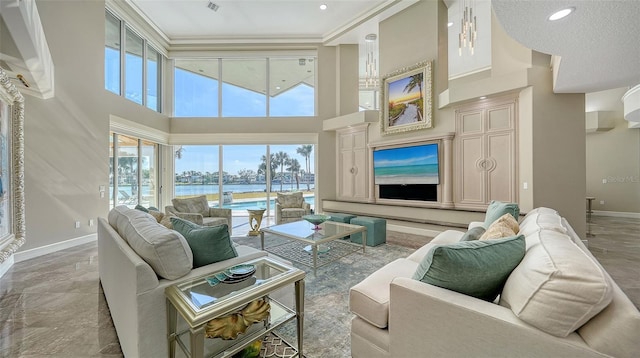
[233, 234, 415, 358]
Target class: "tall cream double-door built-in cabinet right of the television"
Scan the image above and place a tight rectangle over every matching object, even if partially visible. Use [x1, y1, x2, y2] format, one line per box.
[454, 98, 518, 209]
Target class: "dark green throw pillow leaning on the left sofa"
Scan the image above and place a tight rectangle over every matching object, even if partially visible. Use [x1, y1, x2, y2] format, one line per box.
[171, 216, 238, 268]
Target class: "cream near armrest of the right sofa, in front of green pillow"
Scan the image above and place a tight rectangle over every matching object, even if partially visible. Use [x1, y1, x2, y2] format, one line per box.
[389, 277, 606, 357]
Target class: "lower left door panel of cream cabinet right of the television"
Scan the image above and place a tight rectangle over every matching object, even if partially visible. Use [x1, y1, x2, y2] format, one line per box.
[458, 136, 485, 204]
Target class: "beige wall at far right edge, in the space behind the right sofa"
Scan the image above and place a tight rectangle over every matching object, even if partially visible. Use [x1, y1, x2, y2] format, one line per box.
[586, 88, 640, 217]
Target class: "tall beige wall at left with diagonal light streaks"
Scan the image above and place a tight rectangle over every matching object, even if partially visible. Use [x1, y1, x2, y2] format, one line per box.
[20, 1, 168, 251]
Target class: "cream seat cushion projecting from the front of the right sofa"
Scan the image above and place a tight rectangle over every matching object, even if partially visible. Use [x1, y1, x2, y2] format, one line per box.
[349, 259, 418, 328]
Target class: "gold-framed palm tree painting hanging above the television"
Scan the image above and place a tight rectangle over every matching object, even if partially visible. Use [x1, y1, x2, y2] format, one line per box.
[380, 61, 433, 135]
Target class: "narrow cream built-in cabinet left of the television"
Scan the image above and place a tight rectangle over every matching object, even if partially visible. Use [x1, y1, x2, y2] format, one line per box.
[336, 124, 370, 201]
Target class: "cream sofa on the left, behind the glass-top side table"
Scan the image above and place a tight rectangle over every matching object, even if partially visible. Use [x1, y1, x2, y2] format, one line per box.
[98, 206, 267, 358]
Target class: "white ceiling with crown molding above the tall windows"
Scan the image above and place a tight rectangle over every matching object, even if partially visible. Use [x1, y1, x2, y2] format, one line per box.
[126, 0, 417, 45]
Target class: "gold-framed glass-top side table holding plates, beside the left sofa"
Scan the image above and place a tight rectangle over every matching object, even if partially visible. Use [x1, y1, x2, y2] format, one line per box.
[165, 257, 305, 358]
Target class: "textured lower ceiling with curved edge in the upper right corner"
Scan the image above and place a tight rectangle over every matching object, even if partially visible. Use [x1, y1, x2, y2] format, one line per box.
[492, 0, 640, 93]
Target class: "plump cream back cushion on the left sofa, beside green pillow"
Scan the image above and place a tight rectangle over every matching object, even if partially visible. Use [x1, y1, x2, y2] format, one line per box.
[109, 207, 193, 280]
